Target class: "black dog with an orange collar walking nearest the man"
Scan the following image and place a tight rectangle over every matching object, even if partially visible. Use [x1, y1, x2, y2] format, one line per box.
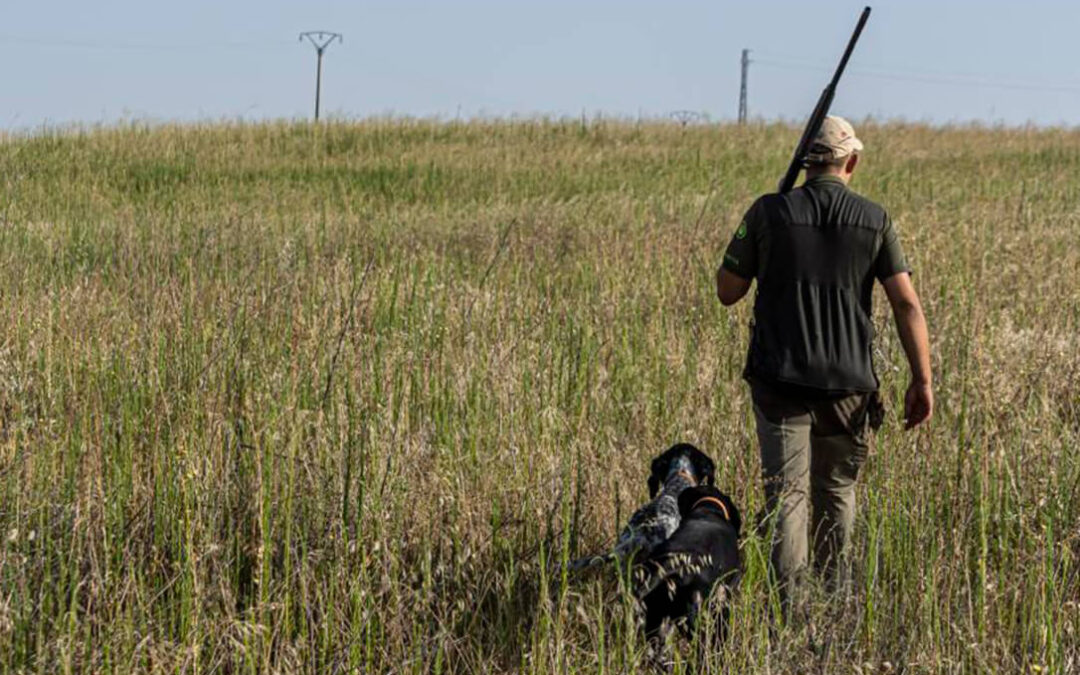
[634, 487, 742, 646]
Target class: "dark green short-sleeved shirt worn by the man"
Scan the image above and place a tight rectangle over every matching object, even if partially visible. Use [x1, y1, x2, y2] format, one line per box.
[740, 176, 906, 393]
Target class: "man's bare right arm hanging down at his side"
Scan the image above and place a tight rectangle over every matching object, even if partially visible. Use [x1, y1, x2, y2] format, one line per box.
[882, 272, 934, 429]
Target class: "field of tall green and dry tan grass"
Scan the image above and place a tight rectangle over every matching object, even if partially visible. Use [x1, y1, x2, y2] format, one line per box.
[0, 121, 1080, 674]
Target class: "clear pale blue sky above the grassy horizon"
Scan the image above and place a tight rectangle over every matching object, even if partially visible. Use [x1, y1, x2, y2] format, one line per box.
[0, 0, 1080, 129]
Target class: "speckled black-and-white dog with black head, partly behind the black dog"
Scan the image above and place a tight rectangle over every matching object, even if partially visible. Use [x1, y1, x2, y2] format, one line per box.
[569, 443, 716, 571]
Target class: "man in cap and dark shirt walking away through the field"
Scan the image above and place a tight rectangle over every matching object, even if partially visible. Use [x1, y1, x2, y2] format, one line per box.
[716, 117, 933, 613]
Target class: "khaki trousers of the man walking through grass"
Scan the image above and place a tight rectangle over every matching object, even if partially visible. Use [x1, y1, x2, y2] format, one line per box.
[753, 384, 870, 613]
